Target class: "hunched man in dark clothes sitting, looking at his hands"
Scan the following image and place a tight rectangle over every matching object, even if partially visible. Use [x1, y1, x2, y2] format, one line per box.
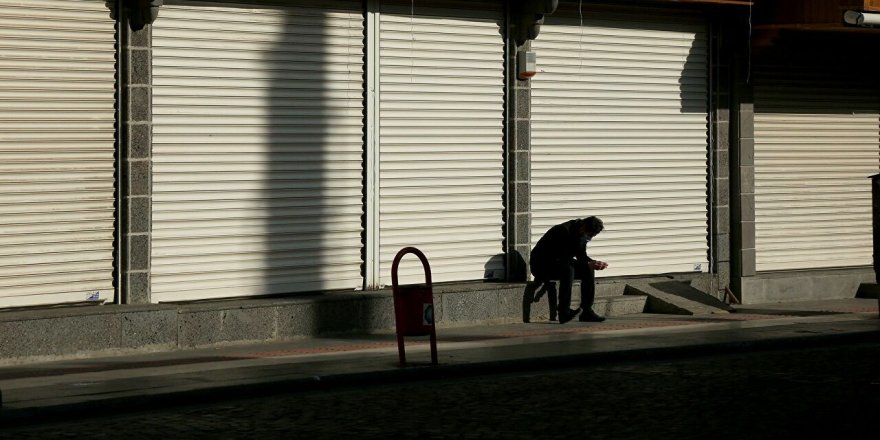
[529, 216, 608, 324]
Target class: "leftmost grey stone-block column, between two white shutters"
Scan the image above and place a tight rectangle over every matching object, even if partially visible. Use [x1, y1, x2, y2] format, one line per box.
[120, 20, 153, 304]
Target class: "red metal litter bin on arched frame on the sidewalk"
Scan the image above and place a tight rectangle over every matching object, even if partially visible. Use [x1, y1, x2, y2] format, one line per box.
[391, 247, 437, 365]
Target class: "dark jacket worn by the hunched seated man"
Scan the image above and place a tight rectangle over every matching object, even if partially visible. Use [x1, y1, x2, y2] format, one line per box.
[529, 219, 593, 268]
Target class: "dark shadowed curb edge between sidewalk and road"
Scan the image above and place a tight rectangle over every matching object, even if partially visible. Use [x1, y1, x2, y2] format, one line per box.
[0, 329, 880, 429]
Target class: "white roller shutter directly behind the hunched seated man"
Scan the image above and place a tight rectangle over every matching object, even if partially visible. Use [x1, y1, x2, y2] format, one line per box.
[531, 11, 708, 276]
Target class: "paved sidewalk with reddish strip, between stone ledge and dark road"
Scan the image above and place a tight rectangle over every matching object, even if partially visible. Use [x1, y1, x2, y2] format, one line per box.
[0, 299, 880, 426]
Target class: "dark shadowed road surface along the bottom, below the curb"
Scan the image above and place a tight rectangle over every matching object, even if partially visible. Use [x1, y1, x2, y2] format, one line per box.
[0, 341, 880, 440]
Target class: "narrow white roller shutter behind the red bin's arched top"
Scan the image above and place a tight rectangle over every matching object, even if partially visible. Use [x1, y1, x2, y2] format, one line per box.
[379, 2, 504, 283]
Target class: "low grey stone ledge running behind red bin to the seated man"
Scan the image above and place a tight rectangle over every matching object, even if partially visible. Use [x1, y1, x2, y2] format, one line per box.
[0, 280, 700, 365]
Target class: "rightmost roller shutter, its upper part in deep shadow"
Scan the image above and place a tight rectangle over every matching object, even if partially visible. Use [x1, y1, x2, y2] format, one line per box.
[754, 67, 880, 271]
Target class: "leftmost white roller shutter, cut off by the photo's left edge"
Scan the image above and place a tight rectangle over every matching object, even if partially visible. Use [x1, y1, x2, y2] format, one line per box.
[0, 0, 116, 307]
